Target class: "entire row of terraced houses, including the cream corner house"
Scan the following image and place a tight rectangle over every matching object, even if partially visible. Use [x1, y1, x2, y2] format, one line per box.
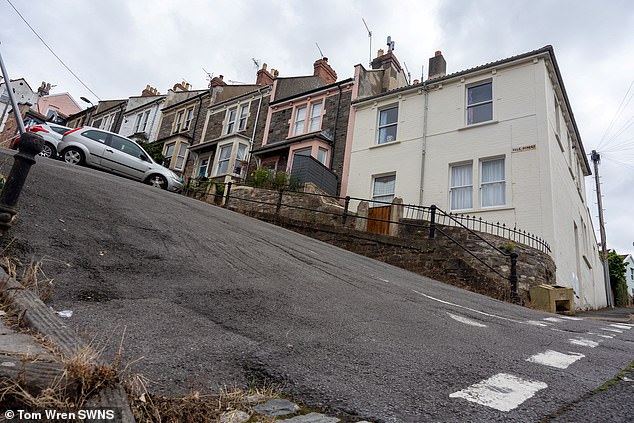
[63, 46, 607, 308]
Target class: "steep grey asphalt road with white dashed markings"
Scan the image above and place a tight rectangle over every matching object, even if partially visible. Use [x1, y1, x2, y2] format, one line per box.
[0, 152, 634, 422]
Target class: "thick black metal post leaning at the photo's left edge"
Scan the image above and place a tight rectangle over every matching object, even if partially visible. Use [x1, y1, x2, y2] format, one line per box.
[0, 132, 44, 234]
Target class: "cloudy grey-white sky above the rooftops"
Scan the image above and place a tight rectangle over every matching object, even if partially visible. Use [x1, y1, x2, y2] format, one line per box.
[0, 0, 634, 253]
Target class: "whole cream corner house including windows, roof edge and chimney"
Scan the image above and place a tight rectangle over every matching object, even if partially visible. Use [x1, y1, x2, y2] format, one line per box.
[347, 46, 607, 308]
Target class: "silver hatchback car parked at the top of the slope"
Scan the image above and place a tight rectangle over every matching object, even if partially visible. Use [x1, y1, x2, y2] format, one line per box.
[58, 126, 183, 191]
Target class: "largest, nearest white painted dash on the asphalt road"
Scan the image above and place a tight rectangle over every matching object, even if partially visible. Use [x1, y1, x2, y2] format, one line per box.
[449, 373, 548, 411]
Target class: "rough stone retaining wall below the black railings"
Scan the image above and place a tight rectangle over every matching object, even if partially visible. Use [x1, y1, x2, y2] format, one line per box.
[222, 187, 555, 303]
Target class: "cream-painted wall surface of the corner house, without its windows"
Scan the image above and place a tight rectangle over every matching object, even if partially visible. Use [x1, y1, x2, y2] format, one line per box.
[347, 57, 607, 308]
